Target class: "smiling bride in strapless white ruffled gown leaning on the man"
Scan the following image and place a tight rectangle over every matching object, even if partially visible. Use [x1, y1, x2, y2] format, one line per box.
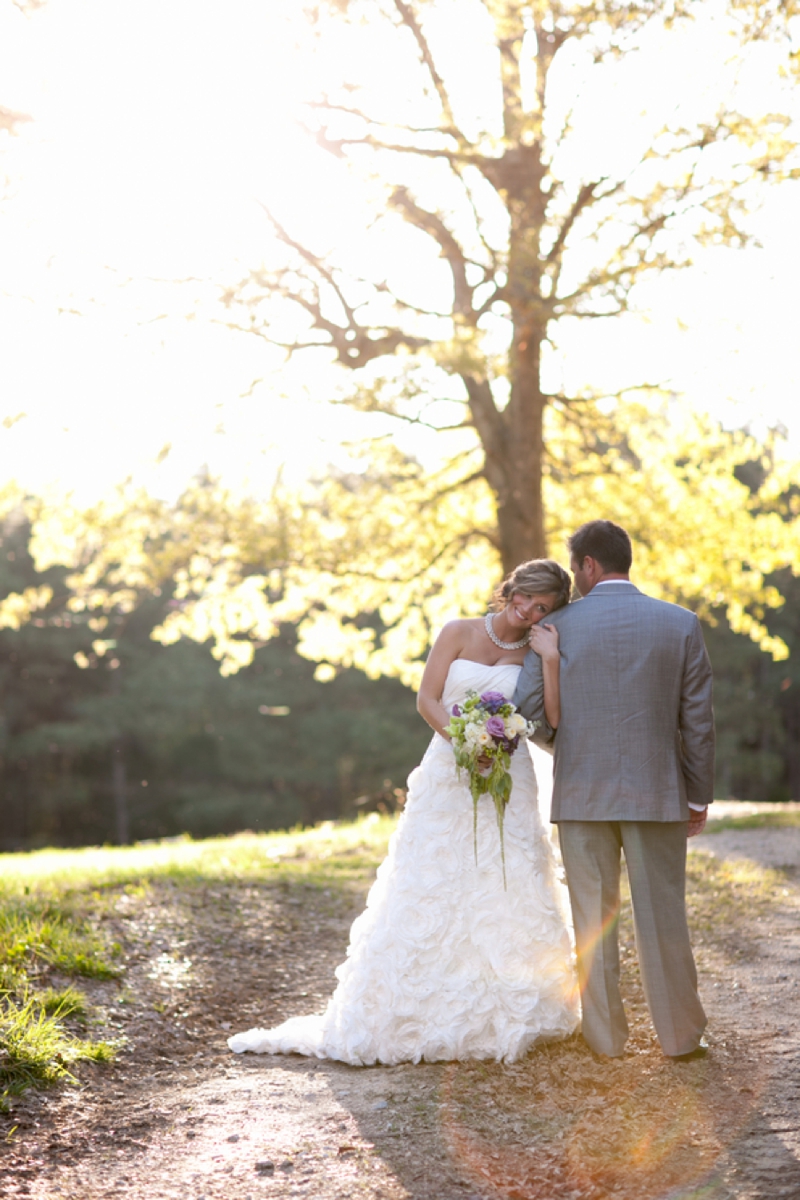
[228, 559, 578, 1066]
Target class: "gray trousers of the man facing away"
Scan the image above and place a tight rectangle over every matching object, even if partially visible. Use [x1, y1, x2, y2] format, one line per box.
[559, 821, 705, 1057]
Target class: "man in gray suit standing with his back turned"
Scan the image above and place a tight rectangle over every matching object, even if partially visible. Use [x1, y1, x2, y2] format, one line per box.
[513, 521, 714, 1060]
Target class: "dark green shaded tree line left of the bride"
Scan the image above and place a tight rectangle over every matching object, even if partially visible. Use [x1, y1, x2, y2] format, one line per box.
[0, 502, 429, 848]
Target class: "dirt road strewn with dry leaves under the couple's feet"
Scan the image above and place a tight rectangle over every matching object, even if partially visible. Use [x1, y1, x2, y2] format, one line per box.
[0, 829, 800, 1200]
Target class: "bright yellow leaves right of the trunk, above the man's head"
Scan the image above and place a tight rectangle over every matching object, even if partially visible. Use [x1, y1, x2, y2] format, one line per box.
[549, 400, 800, 660]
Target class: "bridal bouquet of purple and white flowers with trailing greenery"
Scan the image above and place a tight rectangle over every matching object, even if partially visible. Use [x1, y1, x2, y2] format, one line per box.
[446, 691, 537, 887]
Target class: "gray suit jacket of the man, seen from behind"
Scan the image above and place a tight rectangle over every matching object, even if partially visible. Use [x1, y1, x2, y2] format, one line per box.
[513, 580, 714, 821]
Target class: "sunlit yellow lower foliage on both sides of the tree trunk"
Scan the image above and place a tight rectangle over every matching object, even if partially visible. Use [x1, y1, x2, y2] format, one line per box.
[9, 415, 800, 685]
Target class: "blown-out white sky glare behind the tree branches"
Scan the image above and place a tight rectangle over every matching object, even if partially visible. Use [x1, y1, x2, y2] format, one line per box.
[0, 0, 800, 497]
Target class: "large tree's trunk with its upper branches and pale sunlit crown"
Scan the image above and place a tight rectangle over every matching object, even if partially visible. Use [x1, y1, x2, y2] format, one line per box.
[225, 0, 798, 570]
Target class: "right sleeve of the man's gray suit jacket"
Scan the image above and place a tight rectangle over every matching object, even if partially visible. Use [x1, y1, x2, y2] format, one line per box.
[679, 618, 715, 805]
